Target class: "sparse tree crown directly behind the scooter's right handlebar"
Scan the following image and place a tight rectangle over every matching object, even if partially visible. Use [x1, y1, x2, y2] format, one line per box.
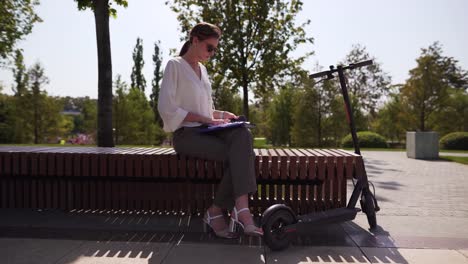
[342, 45, 391, 113]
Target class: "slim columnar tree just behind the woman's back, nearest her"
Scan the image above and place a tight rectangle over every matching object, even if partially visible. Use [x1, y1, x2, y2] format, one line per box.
[150, 41, 163, 127]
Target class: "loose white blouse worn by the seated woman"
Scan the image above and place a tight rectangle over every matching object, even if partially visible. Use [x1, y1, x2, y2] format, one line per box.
[158, 57, 214, 132]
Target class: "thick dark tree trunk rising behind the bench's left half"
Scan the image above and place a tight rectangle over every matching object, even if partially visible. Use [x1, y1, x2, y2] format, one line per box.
[94, 0, 114, 147]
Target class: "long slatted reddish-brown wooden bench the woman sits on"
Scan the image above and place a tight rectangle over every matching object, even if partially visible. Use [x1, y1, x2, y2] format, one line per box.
[0, 147, 362, 214]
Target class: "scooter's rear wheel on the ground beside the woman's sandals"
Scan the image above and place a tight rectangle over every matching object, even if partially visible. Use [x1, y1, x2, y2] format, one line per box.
[263, 209, 296, 251]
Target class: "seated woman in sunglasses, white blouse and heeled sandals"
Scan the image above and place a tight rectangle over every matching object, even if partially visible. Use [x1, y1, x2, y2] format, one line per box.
[158, 23, 263, 238]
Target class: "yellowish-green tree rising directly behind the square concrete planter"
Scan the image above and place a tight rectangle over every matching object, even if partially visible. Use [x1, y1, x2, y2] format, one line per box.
[401, 42, 468, 131]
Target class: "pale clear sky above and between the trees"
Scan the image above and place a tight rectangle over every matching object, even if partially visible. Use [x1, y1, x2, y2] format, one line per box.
[0, 0, 468, 98]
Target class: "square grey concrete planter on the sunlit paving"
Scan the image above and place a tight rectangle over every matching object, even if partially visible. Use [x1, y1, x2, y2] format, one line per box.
[406, 132, 439, 159]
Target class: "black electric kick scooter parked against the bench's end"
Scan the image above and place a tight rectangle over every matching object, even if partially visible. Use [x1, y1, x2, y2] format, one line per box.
[261, 60, 380, 250]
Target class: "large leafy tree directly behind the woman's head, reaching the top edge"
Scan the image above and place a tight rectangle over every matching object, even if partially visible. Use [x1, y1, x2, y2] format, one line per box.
[166, 0, 313, 118]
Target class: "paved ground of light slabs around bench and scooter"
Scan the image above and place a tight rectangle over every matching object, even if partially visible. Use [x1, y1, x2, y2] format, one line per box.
[0, 151, 468, 264]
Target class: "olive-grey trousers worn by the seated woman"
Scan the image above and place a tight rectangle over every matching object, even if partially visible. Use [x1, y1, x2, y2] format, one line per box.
[173, 127, 257, 210]
